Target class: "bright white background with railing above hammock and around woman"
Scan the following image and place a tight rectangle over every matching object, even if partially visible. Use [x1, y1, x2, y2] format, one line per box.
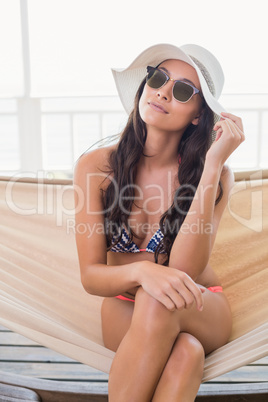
[0, 0, 268, 178]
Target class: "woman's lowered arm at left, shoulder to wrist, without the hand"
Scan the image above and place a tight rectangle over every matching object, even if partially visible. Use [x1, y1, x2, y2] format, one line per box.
[74, 148, 139, 297]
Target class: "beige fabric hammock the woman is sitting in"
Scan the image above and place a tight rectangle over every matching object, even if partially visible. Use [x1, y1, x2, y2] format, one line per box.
[0, 171, 268, 381]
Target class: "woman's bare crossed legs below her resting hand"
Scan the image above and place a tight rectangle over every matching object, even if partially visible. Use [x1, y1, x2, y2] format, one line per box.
[103, 289, 231, 402]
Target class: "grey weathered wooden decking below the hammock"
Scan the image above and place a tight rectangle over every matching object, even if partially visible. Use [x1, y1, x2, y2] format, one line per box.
[0, 327, 268, 402]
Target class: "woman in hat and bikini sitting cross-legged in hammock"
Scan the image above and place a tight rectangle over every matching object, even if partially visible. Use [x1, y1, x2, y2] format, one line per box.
[75, 44, 244, 402]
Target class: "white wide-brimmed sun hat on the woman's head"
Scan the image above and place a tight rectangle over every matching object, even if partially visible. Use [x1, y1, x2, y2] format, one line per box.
[112, 43, 225, 120]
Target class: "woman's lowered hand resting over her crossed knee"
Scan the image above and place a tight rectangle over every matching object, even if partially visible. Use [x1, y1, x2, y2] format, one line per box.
[139, 261, 205, 311]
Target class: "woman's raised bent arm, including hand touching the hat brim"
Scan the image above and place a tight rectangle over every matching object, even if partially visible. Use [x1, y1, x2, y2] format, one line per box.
[169, 113, 245, 280]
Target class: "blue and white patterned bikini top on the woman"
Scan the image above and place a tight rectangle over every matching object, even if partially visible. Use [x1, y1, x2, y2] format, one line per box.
[110, 228, 164, 253]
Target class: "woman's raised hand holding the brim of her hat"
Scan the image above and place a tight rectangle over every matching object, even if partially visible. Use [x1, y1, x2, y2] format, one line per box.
[207, 113, 245, 166]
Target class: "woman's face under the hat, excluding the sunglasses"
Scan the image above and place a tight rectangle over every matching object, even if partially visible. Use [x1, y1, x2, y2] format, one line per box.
[139, 60, 202, 132]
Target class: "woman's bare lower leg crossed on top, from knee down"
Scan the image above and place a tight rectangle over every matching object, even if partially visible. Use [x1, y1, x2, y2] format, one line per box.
[105, 290, 179, 402]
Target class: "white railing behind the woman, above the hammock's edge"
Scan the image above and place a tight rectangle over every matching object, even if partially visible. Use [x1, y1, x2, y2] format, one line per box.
[0, 94, 268, 177]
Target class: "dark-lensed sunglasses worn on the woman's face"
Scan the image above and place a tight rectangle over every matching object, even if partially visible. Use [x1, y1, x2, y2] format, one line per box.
[146, 66, 201, 103]
